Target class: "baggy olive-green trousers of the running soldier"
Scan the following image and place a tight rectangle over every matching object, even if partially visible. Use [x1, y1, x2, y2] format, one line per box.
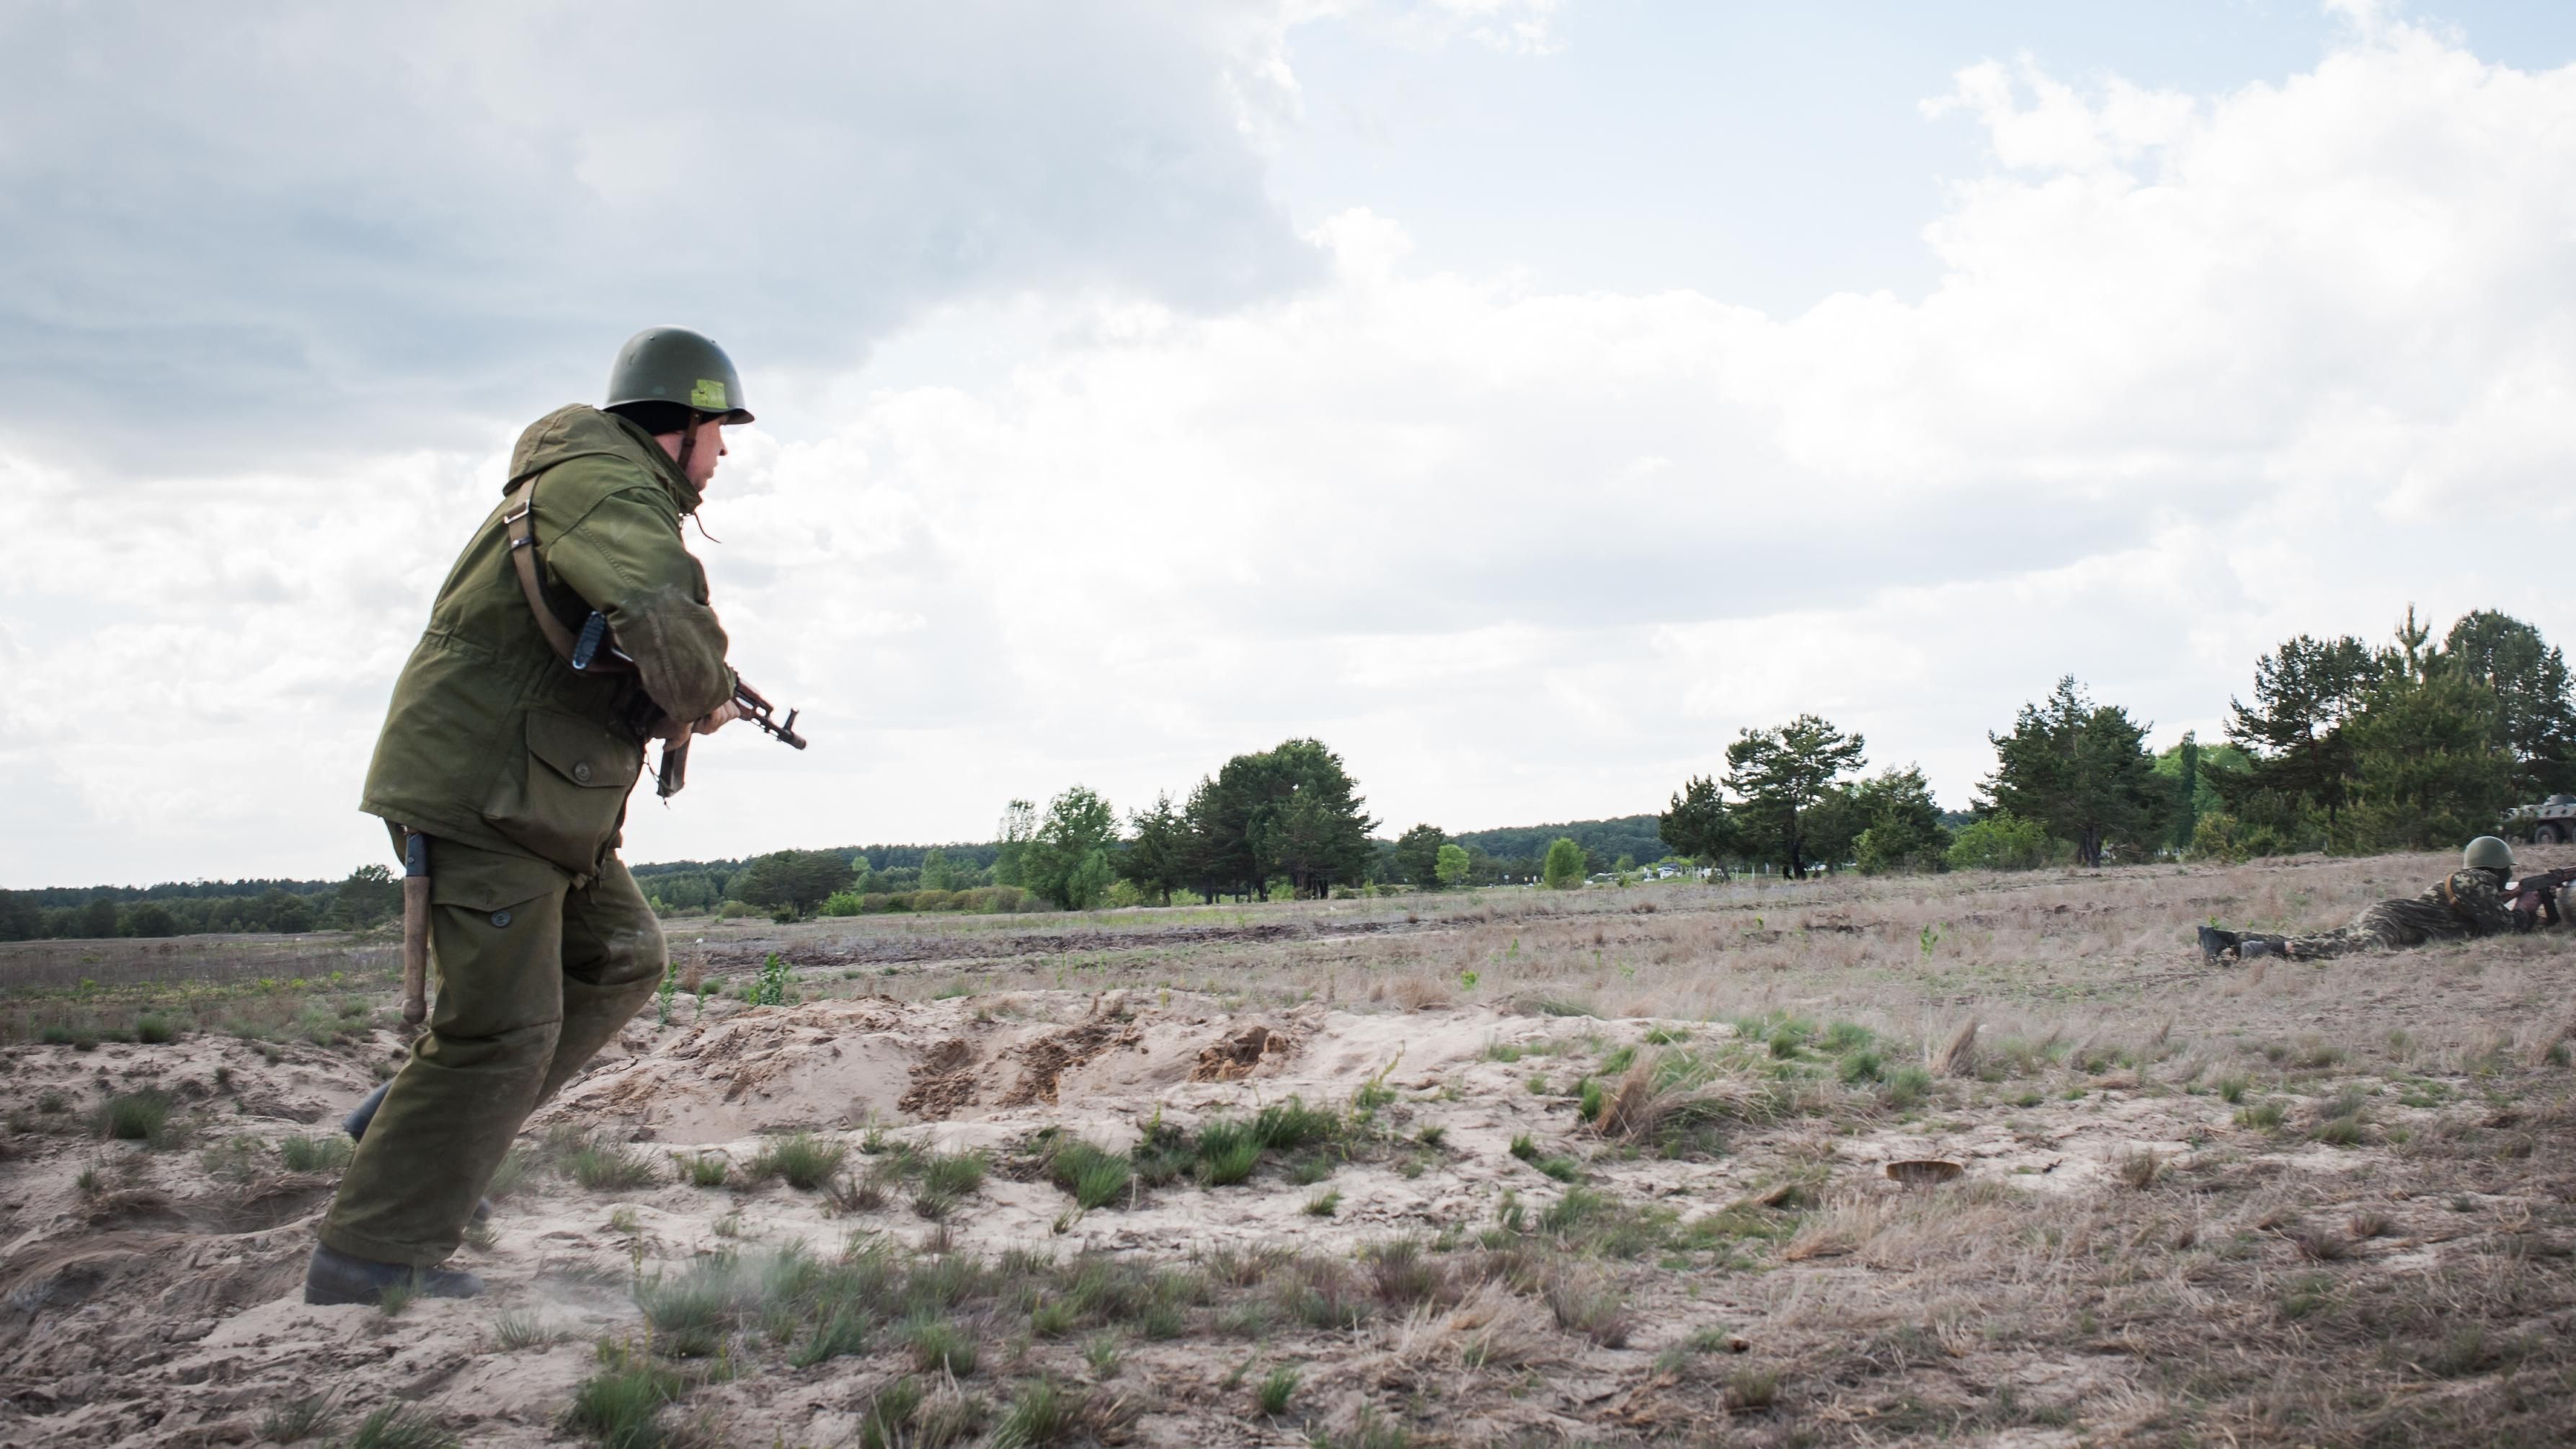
[322, 841, 670, 1269]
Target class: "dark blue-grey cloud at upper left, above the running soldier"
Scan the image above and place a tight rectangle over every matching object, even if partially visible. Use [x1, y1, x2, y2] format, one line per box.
[0, 0, 1311, 469]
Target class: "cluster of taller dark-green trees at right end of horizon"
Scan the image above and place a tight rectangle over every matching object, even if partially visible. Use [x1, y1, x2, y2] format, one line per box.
[1659, 608, 2576, 877]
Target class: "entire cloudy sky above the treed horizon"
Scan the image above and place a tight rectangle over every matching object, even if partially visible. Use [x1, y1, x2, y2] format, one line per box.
[0, 0, 2576, 887]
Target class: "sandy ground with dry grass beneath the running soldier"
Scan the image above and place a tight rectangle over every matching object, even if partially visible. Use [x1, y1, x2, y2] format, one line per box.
[0, 861, 2576, 1446]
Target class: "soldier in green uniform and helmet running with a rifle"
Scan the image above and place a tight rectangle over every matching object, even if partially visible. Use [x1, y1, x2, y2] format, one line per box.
[304, 327, 752, 1302]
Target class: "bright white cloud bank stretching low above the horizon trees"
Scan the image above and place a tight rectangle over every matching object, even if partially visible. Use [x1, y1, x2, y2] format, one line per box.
[0, 11, 2576, 879]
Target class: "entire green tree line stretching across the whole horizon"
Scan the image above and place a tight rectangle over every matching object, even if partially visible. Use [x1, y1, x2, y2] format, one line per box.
[0, 608, 2576, 941]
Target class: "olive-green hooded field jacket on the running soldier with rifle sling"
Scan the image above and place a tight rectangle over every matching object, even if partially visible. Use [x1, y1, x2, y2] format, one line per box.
[358, 405, 734, 887]
